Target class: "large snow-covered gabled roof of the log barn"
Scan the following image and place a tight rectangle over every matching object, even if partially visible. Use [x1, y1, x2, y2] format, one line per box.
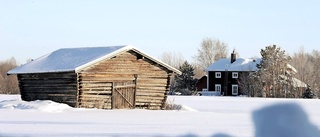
[8, 45, 181, 74]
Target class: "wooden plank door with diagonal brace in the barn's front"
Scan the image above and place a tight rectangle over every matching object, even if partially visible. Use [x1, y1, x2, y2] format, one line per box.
[112, 81, 136, 109]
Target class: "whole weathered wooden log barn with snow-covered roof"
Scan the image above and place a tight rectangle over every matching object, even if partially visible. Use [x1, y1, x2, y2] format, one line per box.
[8, 45, 181, 109]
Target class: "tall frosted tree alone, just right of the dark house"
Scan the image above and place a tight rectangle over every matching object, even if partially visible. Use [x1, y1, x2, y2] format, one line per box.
[253, 45, 295, 97]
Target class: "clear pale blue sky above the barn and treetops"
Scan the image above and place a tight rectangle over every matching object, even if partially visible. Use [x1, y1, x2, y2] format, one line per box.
[0, 0, 320, 64]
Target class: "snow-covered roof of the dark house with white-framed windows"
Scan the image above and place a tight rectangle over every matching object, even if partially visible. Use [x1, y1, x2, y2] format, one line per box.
[206, 58, 261, 71]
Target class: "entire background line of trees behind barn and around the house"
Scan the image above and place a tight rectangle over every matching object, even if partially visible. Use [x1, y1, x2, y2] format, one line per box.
[0, 38, 320, 98]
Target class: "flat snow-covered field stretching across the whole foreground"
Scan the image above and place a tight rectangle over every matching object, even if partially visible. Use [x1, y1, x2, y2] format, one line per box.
[0, 95, 320, 137]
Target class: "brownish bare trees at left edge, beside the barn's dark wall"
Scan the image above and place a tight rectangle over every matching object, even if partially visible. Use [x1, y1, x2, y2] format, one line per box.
[0, 58, 19, 94]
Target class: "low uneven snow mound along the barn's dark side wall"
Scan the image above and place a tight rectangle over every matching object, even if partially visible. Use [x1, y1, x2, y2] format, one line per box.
[0, 99, 71, 112]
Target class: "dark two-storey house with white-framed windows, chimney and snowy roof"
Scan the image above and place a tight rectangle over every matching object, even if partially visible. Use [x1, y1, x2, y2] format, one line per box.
[203, 53, 261, 96]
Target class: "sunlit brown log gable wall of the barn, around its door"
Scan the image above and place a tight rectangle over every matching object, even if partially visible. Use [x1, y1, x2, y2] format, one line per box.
[78, 51, 172, 109]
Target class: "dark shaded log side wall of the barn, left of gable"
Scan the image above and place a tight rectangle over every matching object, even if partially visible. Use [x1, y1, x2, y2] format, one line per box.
[18, 72, 77, 107]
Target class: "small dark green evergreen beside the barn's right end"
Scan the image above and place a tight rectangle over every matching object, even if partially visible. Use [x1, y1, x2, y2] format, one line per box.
[174, 61, 196, 95]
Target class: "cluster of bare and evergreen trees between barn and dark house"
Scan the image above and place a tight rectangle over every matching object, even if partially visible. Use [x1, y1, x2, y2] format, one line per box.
[160, 38, 228, 95]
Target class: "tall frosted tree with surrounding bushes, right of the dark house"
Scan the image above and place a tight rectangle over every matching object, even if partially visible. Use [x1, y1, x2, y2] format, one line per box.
[239, 45, 307, 98]
